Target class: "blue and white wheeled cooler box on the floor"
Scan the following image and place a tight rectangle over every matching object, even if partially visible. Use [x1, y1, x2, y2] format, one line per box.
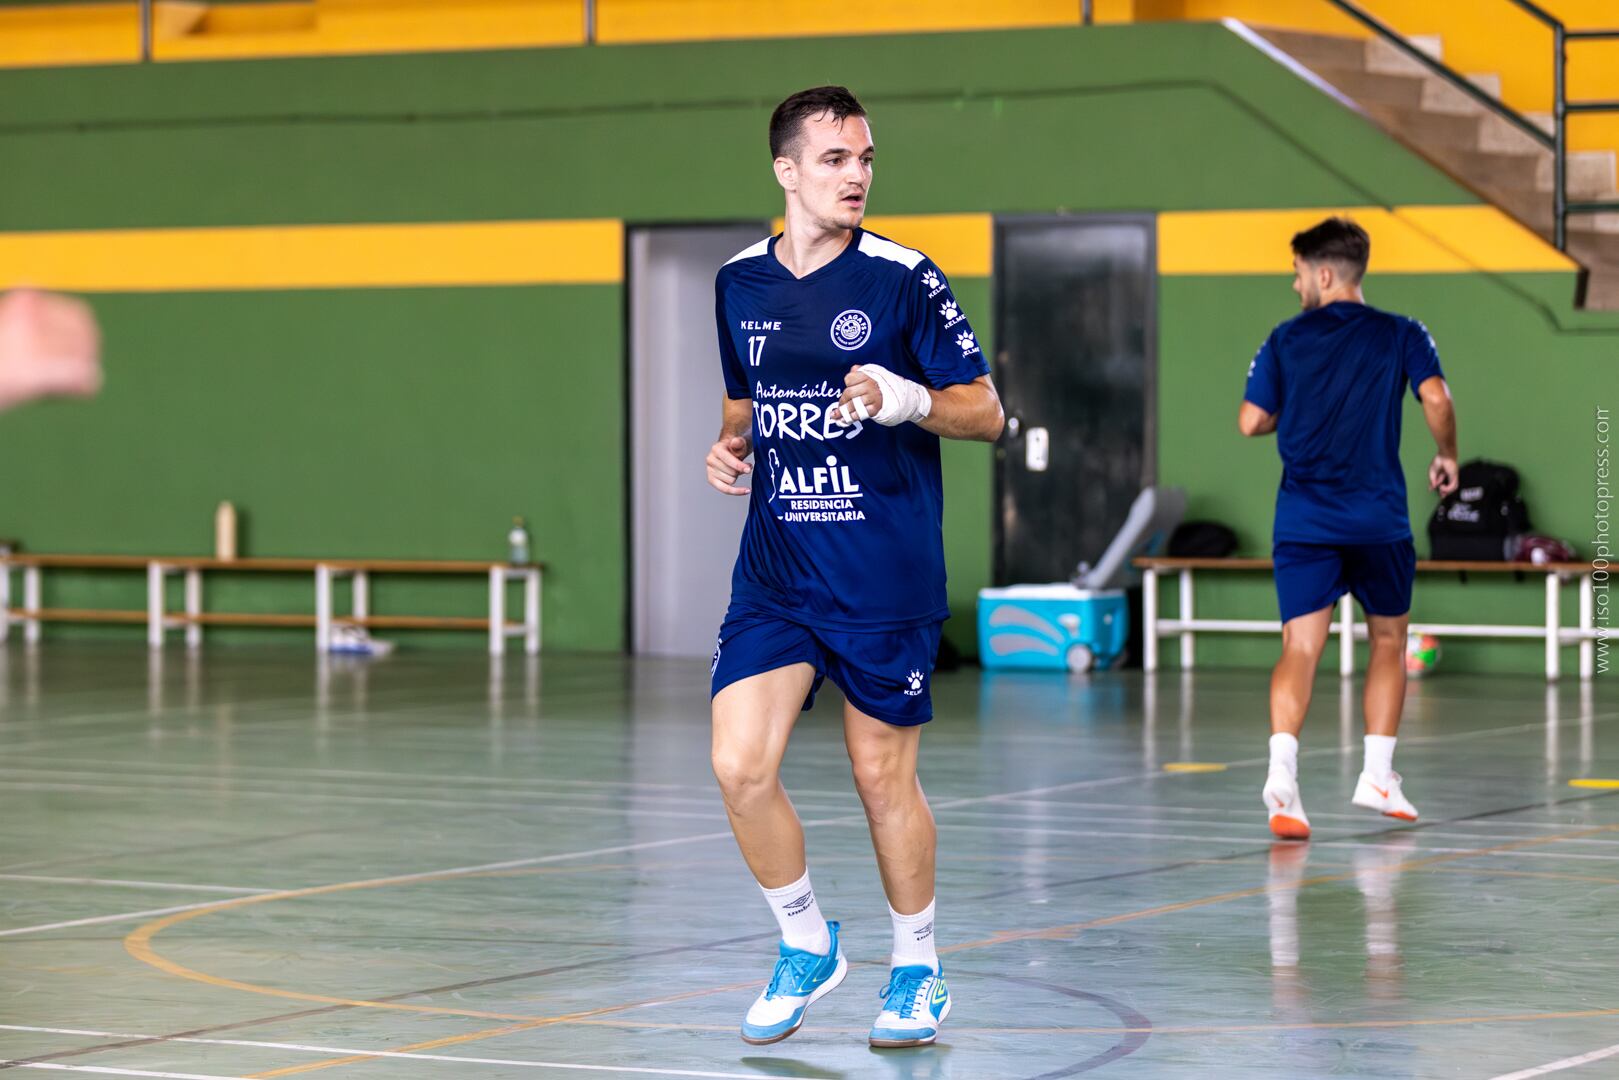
[978, 583, 1130, 672]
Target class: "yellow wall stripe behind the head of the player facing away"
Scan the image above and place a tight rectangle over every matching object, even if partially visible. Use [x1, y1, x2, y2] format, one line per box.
[1158, 206, 1575, 275]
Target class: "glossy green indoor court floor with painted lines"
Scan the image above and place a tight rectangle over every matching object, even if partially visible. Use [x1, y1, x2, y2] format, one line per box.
[0, 643, 1619, 1080]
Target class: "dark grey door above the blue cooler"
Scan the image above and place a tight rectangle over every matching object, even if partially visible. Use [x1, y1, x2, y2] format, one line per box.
[996, 215, 1158, 585]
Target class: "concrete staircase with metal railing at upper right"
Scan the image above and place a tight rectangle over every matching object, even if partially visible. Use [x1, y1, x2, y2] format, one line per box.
[1256, 28, 1619, 311]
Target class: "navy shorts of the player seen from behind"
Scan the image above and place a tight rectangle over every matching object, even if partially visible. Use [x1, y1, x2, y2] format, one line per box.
[1274, 538, 1417, 622]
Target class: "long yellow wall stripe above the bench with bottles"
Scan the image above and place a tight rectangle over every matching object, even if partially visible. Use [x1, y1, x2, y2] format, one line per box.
[0, 220, 623, 293]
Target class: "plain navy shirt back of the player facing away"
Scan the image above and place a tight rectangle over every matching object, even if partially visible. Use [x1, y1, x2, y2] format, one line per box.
[1243, 301, 1444, 544]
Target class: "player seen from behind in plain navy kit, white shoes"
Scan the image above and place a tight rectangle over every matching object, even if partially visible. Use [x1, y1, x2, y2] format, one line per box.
[1237, 217, 1457, 840]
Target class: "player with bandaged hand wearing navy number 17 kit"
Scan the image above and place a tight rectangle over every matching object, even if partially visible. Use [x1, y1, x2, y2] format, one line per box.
[708, 86, 1002, 1046]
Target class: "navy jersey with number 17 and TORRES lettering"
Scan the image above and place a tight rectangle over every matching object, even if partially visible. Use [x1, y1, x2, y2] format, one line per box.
[714, 228, 989, 630]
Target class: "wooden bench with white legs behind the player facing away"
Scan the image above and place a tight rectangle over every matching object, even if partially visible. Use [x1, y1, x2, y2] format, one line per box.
[1135, 557, 1604, 680]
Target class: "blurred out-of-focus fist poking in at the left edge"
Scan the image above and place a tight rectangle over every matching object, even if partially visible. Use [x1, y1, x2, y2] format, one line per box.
[0, 288, 102, 410]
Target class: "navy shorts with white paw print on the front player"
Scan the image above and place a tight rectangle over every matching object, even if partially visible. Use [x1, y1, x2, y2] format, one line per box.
[709, 607, 944, 727]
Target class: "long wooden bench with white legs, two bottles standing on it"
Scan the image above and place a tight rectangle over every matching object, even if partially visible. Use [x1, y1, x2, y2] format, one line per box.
[0, 554, 544, 656]
